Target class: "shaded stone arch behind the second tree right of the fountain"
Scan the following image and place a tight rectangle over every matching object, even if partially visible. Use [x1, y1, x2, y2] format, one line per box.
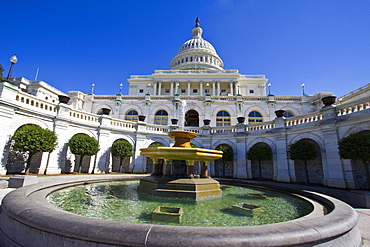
[247, 141, 274, 180]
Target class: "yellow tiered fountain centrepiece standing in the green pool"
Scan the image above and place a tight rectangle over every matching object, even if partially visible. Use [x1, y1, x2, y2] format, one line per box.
[139, 131, 222, 200]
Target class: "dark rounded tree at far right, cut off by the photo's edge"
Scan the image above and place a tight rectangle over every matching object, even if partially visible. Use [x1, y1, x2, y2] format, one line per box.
[338, 133, 370, 188]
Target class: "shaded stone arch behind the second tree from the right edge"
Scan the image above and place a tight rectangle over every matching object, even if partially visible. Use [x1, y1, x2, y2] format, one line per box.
[294, 138, 324, 184]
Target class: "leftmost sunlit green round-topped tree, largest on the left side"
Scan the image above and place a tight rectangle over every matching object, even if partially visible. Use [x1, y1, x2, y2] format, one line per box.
[12, 125, 58, 173]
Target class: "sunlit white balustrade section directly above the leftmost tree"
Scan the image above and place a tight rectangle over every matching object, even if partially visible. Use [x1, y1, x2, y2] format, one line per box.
[15, 92, 57, 115]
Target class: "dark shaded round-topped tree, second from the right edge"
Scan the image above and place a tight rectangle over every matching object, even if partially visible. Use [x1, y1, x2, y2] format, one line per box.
[288, 140, 319, 183]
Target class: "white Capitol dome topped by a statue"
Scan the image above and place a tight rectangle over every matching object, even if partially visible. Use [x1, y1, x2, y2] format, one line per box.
[170, 18, 224, 70]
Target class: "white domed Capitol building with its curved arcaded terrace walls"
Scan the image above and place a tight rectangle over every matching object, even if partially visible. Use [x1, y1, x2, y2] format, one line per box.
[0, 21, 370, 188]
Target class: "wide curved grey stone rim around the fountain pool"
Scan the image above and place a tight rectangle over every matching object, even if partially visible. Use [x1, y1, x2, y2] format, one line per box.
[0, 175, 361, 246]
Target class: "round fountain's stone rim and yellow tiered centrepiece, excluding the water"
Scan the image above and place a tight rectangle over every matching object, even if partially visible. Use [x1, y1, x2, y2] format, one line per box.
[0, 131, 361, 247]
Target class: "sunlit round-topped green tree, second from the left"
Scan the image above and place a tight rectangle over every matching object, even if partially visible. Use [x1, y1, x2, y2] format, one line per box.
[69, 134, 99, 173]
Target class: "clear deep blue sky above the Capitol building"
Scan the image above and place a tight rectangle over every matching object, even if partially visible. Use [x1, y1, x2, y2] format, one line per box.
[0, 0, 370, 97]
